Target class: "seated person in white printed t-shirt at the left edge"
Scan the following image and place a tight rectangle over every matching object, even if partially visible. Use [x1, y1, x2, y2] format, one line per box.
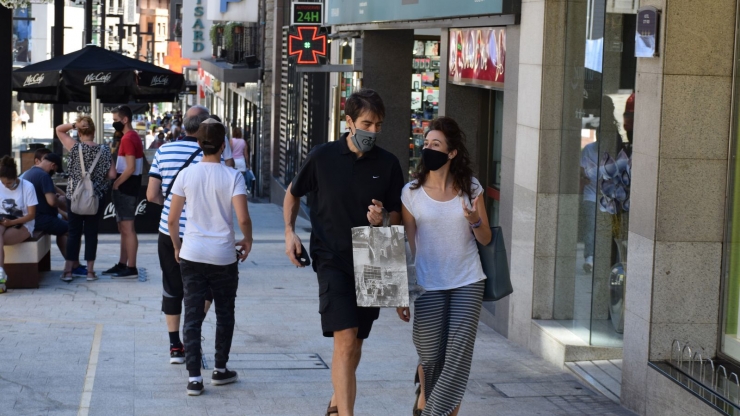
[0, 156, 38, 283]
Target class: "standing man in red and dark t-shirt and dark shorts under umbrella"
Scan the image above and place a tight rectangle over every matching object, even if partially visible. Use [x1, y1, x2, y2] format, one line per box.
[103, 105, 144, 279]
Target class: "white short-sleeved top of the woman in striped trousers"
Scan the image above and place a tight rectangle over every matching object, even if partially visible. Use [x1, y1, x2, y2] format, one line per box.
[401, 178, 486, 291]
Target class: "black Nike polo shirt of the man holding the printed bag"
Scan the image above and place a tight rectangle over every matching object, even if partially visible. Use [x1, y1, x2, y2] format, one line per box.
[291, 133, 405, 274]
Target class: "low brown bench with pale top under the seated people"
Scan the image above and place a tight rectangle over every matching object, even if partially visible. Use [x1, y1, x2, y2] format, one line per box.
[4, 231, 51, 289]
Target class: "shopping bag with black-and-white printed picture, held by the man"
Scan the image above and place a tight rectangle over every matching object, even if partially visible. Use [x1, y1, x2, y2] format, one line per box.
[352, 225, 409, 308]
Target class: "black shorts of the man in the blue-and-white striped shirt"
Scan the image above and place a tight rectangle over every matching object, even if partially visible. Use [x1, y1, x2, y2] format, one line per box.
[157, 232, 213, 315]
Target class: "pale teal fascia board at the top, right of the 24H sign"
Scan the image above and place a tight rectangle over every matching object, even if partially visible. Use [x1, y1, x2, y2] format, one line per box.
[326, 0, 521, 26]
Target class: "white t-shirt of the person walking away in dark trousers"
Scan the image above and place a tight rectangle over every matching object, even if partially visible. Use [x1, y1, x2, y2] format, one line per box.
[172, 161, 247, 266]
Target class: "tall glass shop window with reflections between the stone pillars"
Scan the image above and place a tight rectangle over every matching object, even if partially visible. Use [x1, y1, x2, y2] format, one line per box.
[552, 0, 636, 347]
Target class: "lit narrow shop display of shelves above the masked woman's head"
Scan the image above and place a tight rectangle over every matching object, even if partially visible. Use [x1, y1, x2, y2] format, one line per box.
[409, 38, 440, 176]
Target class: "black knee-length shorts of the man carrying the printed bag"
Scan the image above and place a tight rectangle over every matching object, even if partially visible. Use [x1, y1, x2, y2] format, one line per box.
[316, 259, 380, 339]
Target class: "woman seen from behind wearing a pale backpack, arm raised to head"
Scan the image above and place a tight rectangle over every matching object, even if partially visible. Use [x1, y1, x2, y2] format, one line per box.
[56, 116, 116, 282]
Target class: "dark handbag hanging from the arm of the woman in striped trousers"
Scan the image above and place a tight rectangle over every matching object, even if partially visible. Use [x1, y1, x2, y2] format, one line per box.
[477, 227, 514, 302]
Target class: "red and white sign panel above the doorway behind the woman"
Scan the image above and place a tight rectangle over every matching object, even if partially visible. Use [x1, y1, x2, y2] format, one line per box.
[447, 28, 506, 90]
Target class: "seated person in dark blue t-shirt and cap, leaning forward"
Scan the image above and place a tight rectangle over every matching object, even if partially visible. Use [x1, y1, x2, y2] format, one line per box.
[21, 148, 71, 277]
